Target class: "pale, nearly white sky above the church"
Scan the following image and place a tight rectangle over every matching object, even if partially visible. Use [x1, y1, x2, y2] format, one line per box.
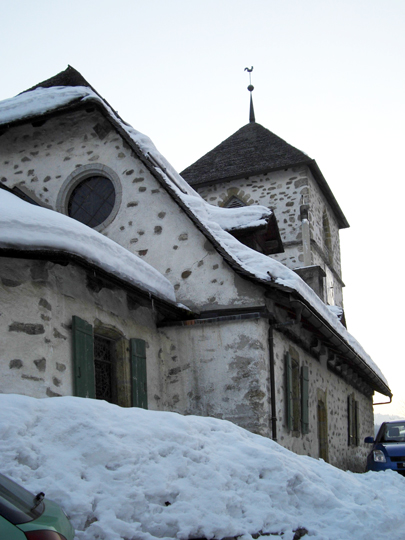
[0, 0, 405, 416]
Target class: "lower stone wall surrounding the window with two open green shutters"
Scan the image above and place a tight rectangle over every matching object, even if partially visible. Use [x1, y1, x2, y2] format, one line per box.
[0, 258, 172, 409]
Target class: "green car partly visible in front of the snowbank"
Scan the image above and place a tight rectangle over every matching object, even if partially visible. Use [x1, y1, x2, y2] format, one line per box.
[0, 473, 75, 540]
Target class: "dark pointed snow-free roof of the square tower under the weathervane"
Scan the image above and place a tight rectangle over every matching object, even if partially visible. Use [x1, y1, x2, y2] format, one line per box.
[180, 122, 349, 229]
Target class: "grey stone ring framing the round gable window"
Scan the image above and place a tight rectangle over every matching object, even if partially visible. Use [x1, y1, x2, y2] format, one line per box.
[56, 163, 122, 232]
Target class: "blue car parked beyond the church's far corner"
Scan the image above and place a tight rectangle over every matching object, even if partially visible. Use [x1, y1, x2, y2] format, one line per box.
[364, 420, 405, 476]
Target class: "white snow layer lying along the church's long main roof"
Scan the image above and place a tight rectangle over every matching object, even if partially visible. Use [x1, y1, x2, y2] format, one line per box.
[0, 76, 390, 395]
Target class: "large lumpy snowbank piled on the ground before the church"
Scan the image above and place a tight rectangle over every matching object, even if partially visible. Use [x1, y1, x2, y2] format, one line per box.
[0, 394, 405, 540]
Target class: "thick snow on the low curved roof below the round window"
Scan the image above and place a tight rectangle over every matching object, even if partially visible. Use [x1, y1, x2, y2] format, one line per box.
[0, 189, 176, 302]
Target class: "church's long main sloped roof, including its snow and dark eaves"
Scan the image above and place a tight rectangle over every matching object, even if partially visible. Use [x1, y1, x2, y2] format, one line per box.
[0, 67, 391, 396]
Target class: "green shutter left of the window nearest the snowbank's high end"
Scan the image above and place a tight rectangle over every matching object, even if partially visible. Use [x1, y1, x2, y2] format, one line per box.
[72, 315, 96, 398]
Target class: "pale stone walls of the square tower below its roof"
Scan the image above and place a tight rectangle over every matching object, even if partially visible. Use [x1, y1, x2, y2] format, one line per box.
[191, 166, 343, 306]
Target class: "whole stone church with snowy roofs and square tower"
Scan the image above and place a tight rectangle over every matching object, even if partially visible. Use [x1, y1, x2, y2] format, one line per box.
[0, 67, 391, 471]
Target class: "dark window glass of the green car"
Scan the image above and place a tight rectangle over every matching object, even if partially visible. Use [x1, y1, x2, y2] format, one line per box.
[0, 473, 44, 525]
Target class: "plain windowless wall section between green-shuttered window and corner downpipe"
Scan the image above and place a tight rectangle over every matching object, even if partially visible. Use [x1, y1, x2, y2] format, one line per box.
[161, 319, 271, 436]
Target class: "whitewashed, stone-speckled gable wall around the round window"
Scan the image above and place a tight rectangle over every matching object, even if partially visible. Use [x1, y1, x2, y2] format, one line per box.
[0, 112, 260, 308]
